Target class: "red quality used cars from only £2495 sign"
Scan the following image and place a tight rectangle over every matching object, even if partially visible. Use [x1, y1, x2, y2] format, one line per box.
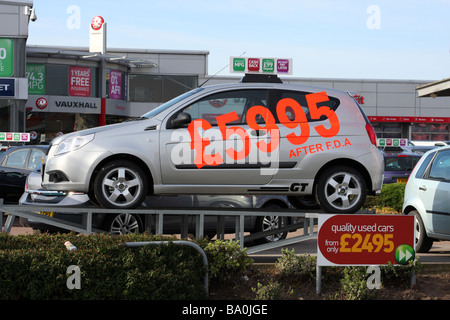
[317, 214, 415, 266]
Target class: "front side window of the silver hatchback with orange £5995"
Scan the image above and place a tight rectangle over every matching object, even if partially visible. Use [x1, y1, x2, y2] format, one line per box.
[183, 89, 268, 126]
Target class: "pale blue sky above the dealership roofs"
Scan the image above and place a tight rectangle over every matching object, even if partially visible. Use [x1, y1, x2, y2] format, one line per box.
[27, 0, 450, 81]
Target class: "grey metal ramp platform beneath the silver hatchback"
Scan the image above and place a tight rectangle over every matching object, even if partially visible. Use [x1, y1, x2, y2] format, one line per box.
[0, 199, 321, 254]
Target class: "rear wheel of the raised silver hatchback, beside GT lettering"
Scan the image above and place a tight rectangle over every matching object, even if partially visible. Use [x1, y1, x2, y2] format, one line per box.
[316, 166, 367, 213]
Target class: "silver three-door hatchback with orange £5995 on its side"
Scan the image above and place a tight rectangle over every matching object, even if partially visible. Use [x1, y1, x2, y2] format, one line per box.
[42, 76, 384, 213]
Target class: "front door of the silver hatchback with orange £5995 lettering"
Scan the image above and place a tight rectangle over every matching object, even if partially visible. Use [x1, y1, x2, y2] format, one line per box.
[160, 89, 272, 185]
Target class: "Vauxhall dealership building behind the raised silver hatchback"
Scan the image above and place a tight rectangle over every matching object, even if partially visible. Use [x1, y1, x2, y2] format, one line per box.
[0, 1, 450, 143]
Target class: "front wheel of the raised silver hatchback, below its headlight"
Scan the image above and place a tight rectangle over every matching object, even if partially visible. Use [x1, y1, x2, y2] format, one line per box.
[94, 160, 148, 209]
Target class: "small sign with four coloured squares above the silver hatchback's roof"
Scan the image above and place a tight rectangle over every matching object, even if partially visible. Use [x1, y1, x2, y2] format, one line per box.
[230, 57, 293, 74]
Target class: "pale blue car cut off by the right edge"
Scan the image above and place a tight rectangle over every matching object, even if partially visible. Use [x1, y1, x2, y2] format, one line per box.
[402, 147, 450, 252]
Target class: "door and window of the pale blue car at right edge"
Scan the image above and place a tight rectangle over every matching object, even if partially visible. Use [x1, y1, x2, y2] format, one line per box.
[419, 150, 450, 234]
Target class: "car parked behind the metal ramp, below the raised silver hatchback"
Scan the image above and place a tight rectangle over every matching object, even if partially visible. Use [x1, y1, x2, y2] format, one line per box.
[19, 167, 302, 243]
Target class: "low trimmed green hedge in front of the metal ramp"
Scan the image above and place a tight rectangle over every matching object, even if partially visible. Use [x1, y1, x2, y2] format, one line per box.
[0, 233, 250, 300]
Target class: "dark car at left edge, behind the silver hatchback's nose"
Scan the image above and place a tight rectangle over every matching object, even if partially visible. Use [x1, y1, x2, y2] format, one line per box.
[0, 145, 49, 204]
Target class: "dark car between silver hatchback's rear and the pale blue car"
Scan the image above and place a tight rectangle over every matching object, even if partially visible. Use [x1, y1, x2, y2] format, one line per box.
[383, 148, 421, 184]
